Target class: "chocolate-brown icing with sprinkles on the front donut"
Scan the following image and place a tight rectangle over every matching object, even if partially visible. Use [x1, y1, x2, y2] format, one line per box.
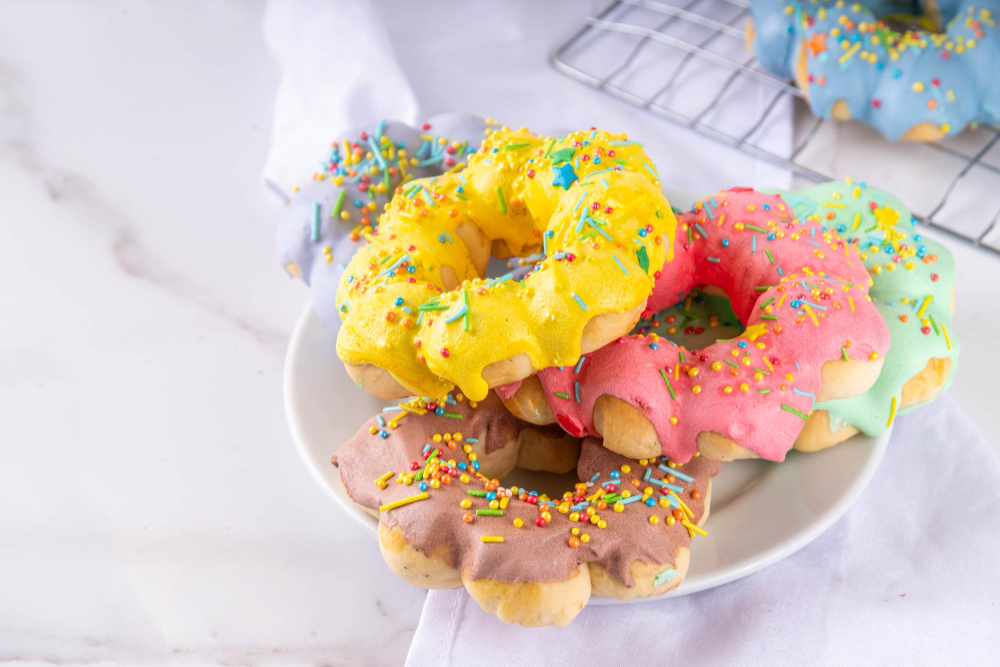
[333, 393, 719, 585]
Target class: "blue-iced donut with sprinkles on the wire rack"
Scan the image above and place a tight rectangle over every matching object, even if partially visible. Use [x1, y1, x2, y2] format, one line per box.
[747, 0, 1000, 141]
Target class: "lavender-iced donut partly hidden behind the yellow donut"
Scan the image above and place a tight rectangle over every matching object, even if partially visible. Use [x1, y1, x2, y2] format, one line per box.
[277, 113, 498, 340]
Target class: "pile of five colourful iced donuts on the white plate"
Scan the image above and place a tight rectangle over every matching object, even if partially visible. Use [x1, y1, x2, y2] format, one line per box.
[278, 116, 958, 626]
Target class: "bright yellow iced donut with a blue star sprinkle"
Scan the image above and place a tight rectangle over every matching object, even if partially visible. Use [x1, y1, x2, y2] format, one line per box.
[337, 128, 676, 400]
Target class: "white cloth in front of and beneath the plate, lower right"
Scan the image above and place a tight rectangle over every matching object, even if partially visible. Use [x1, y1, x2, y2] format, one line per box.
[406, 395, 1000, 667]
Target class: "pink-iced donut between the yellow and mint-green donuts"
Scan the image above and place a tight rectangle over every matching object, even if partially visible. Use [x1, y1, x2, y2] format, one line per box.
[498, 188, 889, 462]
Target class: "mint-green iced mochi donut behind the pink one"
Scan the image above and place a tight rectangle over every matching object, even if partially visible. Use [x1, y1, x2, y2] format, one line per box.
[779, 179, 959, 450]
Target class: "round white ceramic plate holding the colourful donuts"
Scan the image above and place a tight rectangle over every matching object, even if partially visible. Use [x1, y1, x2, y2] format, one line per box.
[285, 305, 889, 604]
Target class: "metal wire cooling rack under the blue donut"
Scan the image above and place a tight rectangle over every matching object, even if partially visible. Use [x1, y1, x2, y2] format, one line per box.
[552, 0, 1000, 256]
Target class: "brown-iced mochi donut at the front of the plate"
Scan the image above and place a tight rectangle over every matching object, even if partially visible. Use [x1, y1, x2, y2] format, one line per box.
[333, 392, 719, 626]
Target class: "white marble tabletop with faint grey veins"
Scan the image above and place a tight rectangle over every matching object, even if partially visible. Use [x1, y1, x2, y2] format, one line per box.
[0, 1, 1000, 665]
